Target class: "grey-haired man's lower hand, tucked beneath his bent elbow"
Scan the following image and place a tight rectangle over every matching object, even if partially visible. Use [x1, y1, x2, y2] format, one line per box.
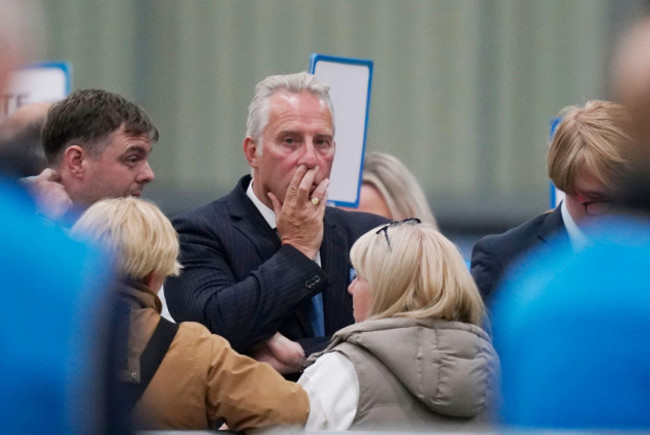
[251, 332, 305, 374]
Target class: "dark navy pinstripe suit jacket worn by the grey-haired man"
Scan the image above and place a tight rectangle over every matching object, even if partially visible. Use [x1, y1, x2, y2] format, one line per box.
[165, 176, 387, 352]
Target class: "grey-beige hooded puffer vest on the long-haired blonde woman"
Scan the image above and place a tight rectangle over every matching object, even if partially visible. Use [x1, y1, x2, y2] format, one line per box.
[310, 318, 500, 431]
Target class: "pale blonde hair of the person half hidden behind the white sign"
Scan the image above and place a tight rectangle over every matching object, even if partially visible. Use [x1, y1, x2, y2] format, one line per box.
[361, 152, 438, 229]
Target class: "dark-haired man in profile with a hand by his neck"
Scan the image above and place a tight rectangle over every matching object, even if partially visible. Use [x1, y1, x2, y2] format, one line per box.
[28, 89, 158, 218]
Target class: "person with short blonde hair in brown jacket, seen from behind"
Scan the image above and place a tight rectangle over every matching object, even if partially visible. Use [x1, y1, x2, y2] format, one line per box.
[71, 197, 309, 431]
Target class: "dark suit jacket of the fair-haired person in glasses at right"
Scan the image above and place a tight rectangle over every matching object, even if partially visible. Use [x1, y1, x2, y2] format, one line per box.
[472, 206, 568, 303]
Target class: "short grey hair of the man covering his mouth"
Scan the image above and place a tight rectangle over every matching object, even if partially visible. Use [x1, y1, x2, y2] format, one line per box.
[246, 72, 334, 152]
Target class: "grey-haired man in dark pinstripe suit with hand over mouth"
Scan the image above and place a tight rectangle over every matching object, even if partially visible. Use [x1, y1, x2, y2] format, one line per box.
[165, 73, 387, 373]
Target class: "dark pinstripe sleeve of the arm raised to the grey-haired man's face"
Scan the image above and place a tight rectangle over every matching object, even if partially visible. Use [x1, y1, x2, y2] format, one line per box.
[165, 213, 327, 352]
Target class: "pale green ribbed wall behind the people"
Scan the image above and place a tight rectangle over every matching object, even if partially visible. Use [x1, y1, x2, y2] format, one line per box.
[31, 0, 642, 232]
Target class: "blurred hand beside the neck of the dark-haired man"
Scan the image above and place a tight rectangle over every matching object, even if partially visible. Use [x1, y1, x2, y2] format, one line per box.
[21, 168, 72, 220]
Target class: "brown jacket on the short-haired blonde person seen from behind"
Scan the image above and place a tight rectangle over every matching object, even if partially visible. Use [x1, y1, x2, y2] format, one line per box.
[118, 285, 309, 431]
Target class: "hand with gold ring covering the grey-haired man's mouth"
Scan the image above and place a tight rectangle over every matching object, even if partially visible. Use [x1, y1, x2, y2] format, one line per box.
[269, 165, 329, 260]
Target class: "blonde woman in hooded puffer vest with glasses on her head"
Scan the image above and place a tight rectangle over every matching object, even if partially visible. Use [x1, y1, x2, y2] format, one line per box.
[298, 219, 499, 431]
